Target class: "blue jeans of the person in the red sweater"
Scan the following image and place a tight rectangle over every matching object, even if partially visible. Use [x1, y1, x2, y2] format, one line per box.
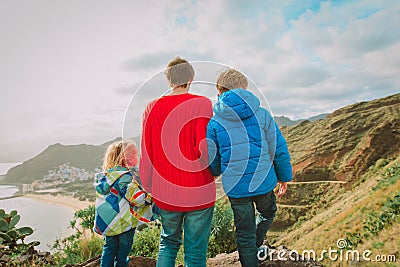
[157, 207, 214, 267]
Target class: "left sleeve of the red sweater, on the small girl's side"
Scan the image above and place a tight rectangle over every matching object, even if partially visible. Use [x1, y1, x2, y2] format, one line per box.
[139, 103, 153, 192]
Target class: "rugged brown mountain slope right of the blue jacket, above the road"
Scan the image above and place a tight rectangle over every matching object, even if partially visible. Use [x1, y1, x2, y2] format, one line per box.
[281, 94, 400, 182]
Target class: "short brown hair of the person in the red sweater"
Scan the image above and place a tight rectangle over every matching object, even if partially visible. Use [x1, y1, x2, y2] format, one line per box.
[165, 57, 194, 88]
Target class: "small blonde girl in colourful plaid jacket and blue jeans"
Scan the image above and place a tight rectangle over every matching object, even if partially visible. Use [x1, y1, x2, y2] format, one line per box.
[94, 141, 153, 267]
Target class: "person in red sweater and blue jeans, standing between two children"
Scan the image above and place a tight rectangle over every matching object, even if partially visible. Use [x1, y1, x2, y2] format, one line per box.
[139, 57, 215, 267]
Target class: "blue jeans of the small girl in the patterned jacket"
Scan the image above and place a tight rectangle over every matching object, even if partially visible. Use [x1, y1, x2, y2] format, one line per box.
[100, 228, 135, 267]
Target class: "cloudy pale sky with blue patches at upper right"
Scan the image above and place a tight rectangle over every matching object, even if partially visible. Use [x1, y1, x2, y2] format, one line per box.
[0, 0, 400, 162]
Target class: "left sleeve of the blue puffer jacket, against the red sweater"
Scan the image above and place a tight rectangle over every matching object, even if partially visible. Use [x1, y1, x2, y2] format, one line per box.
[207, 120, 221, 176]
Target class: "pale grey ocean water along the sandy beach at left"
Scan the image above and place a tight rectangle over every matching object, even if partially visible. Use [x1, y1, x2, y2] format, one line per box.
[0, 163, 75, 252]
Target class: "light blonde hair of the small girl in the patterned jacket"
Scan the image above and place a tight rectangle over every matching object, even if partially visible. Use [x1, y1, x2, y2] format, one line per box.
[103, 140, 138, 170]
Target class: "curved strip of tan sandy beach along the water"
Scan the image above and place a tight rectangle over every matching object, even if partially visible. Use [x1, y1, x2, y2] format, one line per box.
[23, 194, 94, 211]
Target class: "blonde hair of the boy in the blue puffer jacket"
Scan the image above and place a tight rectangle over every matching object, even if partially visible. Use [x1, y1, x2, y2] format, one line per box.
[216, 69, 248, 93]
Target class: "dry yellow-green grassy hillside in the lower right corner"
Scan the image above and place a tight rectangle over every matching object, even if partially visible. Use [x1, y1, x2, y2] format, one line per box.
[276, 157, 400, 266]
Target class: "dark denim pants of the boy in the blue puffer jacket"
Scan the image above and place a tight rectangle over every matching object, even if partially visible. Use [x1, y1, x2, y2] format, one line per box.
[229, 191, 276, 267]
